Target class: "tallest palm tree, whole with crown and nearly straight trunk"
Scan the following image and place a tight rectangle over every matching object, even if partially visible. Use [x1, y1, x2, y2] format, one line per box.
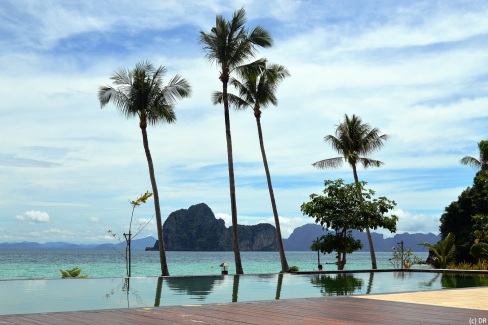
[200, 8, 272, 274]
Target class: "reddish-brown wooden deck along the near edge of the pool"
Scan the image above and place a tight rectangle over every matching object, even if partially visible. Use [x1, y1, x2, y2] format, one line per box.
[0, 291, 488, 325]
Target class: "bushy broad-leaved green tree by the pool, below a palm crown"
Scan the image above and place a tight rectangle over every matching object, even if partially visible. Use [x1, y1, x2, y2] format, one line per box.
[301, 179, 398, 270]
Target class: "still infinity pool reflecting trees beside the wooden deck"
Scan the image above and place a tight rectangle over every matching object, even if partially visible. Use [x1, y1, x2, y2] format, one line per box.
[0, 272, 488, 315]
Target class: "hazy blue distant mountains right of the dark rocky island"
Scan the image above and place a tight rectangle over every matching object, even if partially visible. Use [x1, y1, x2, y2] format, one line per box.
[283, 224, 441, 252]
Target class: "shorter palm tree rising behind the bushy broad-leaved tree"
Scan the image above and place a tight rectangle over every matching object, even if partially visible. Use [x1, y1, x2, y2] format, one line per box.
[312, 114, 388, 270]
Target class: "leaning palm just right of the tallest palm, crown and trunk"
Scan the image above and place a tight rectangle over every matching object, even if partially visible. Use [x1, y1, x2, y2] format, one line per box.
[214, 59, 290, 272]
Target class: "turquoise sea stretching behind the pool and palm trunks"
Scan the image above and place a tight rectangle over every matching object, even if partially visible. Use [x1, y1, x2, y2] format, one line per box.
[0, 249, 428, 280]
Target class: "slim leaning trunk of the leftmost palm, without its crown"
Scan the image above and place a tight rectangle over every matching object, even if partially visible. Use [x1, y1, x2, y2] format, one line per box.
[141, 122, 169, 276]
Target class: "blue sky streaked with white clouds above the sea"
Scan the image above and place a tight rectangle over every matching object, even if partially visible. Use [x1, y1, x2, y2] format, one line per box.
[0, 0, 488, 243]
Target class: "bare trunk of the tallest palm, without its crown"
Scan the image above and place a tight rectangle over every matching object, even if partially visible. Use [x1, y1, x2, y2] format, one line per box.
[222, 76, 244, 274]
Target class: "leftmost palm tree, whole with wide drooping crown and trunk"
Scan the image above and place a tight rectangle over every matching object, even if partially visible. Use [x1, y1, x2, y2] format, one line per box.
[98, 61, 191, 276]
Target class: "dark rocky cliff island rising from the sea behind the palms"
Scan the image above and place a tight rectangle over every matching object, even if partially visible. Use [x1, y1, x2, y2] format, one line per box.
[146, 203, 278, 251]
